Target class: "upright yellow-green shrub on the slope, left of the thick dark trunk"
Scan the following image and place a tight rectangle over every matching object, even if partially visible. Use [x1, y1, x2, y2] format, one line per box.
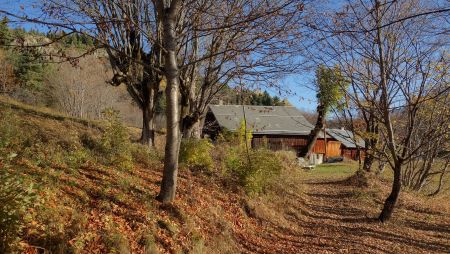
[100, 109, 133, 169]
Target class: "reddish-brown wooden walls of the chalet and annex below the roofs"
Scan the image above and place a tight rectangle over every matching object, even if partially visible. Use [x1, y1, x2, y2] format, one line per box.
[252, 134, 341, 157]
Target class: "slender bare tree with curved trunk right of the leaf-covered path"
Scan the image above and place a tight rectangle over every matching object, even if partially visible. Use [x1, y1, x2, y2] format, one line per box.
[306, 0, 449, 222]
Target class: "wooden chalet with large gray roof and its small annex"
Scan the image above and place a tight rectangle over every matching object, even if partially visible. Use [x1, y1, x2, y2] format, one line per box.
[203, 105, 366, 159]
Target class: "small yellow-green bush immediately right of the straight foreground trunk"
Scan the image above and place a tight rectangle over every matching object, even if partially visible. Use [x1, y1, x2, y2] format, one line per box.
[180, 139, 214, 170]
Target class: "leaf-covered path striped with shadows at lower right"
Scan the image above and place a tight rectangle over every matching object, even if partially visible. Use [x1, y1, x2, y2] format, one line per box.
[237, 179, 450, 253]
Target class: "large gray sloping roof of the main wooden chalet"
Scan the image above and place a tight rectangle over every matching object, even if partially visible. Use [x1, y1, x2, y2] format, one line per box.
[209, 105, 323, 136]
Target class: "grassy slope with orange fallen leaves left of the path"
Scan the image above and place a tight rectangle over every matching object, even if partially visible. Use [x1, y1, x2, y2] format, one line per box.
[0, 97, 284, 253]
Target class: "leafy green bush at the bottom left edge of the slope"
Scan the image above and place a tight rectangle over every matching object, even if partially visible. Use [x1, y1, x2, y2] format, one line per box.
[0, 168, 36, 253]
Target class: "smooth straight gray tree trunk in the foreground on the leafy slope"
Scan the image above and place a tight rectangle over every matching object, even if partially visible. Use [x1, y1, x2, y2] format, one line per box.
[157, 6, 180, 203]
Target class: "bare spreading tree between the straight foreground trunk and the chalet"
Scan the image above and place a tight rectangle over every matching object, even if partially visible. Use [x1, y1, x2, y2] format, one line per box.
[179, 0, 303, 138]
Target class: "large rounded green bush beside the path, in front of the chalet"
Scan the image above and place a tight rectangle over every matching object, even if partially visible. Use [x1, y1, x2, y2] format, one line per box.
[225, 147, 282, 195]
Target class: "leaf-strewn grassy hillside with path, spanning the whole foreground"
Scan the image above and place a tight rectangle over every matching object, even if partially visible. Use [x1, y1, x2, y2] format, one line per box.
[0, 97, 450, 253]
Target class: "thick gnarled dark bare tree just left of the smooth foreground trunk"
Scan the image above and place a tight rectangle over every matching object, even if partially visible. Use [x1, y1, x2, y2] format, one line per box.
[40, 0, 163, 145]
